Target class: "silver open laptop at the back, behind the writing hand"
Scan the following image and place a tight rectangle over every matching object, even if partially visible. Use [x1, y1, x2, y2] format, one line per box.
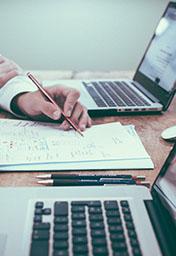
[45, 2, 176, 116]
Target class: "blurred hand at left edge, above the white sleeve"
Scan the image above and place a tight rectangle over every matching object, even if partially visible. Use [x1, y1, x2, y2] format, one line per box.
[0, 55, 22, 88]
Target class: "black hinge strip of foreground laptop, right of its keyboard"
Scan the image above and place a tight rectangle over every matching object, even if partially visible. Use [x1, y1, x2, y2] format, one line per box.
[144, 200, 176, 256]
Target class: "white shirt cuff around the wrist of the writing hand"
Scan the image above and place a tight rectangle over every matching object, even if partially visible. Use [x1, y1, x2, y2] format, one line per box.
[0, 76, 36, 116]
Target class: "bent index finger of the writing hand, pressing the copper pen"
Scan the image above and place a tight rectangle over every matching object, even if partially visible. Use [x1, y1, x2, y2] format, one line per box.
[64, 89, 80, 117]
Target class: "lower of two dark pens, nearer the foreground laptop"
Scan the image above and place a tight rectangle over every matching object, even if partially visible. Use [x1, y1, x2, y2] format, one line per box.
[38, 179, 137, 186]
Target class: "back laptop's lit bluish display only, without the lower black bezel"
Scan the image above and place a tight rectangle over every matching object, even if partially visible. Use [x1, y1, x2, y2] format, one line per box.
[139, 5, 176, 91]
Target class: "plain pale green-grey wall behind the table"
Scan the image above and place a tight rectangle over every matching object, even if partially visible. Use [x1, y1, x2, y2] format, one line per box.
[0, 0, 168, 70]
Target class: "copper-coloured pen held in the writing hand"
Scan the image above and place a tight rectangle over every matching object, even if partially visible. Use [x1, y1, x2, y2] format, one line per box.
[27, 72, 83, 136]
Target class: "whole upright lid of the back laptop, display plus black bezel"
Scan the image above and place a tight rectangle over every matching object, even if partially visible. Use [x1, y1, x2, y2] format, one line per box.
[134, 2, 176, 110]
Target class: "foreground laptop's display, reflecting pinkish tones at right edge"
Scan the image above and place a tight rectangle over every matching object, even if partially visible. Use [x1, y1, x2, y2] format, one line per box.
[153, 144, 176, 224]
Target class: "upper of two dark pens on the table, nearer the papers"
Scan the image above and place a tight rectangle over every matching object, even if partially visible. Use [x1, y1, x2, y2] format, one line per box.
[36, 174, 145, 180]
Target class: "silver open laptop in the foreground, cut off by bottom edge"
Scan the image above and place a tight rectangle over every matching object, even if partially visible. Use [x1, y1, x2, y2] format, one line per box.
[0, 145, 176, 256]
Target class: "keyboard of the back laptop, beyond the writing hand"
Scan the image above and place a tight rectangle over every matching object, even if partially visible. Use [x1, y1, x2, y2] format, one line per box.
[83, 81, 151, 107]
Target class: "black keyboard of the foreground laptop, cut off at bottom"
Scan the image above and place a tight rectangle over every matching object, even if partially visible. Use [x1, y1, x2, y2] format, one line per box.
[30, 200, 142, 256]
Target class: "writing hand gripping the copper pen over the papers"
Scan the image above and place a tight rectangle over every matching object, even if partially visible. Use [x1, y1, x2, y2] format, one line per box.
[13, 86, 91, 131]
